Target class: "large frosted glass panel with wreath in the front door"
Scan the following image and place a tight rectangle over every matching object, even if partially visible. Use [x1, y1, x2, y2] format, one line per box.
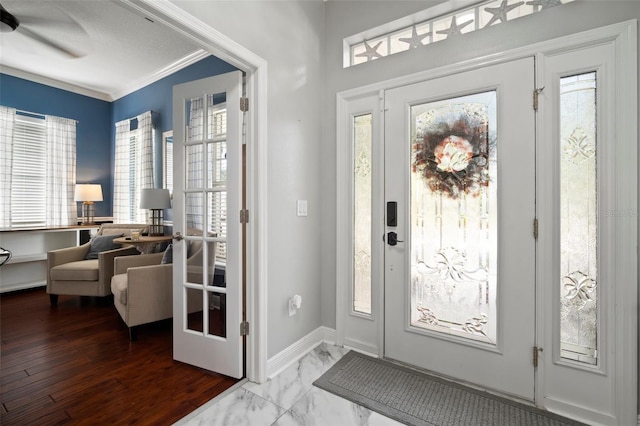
[410, 91, 498, 344]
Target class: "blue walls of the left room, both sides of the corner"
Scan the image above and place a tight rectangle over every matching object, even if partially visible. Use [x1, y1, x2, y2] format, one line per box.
[0, 56, 237, 216]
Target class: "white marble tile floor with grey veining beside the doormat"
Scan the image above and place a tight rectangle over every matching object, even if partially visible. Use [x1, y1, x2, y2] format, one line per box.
[175, 343, 401, 426]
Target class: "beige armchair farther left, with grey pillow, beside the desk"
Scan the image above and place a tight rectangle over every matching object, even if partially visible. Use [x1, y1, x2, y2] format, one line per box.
[47, 223, 147, 306]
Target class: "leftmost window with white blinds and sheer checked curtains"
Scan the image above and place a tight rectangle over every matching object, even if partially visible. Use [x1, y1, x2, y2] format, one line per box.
[0, 107, 77, 228]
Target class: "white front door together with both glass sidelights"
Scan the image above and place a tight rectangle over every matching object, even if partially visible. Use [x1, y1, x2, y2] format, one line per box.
[336, 23, 637, 424]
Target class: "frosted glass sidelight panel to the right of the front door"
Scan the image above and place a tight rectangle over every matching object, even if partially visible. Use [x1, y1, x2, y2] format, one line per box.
[559, 72, 598, 364]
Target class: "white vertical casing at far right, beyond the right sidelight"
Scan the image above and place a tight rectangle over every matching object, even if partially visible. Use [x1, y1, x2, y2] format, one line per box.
[613, 20, 638, 424]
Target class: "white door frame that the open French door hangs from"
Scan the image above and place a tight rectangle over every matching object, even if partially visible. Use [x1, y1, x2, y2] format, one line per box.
[122, 0, 268, 383]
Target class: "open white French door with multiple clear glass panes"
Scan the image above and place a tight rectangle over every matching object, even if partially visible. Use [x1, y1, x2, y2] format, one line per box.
[173, 71, 243, 378]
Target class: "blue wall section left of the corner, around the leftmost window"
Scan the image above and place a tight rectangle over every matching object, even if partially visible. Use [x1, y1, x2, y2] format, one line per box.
[0, 74, 112, 216]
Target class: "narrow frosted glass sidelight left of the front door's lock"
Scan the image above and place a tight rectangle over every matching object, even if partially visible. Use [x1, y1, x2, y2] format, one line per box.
[353, 114, 371, 314]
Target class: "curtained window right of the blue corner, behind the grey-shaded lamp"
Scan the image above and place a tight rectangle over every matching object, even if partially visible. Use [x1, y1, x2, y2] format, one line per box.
[113, 111, 154, 223]
